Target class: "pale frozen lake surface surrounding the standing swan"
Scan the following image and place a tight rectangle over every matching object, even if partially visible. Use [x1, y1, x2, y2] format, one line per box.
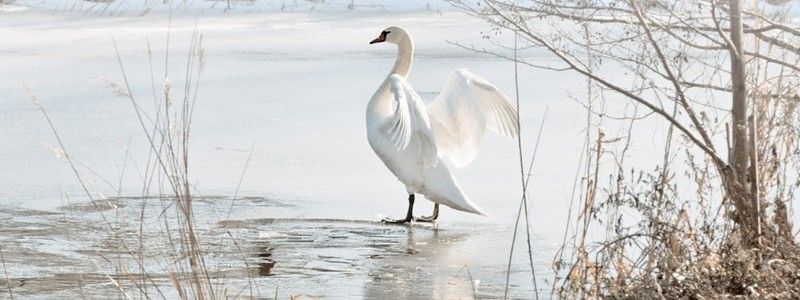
[0, 1, 624, 299]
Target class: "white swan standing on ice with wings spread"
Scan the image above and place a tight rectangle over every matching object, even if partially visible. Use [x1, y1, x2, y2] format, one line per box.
[367, 26, 518, 223]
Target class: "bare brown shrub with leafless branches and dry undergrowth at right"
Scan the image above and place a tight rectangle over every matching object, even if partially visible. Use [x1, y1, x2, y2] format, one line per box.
[451, 0, 800, 298]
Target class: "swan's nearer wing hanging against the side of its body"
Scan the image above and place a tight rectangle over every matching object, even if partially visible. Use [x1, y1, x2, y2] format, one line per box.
[381, 74, 439, 167]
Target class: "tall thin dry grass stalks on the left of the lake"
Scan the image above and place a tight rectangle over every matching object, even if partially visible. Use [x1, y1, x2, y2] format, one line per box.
[21, 27, 256, 299]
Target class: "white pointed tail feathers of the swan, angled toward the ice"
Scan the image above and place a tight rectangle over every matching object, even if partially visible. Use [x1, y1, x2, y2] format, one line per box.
[422, 160, 485, 216]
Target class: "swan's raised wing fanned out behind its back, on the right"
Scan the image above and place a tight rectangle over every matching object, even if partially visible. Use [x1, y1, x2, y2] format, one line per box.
[427, 69, 519, 167]
